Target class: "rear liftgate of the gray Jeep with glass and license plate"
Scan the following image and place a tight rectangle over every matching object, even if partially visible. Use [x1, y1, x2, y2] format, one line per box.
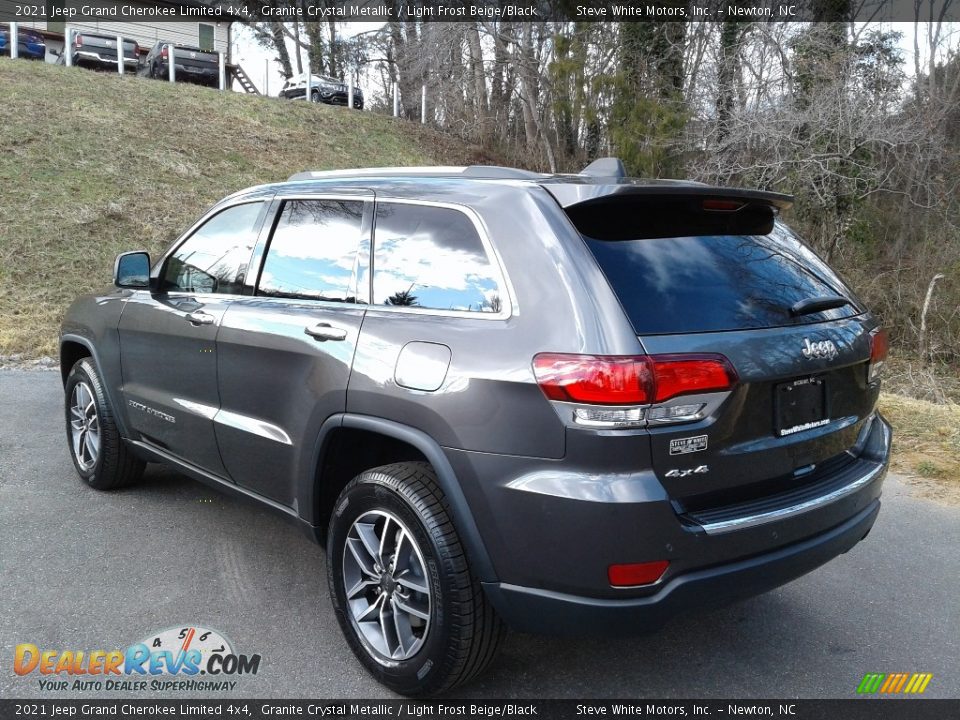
[575, 194, 876, 509]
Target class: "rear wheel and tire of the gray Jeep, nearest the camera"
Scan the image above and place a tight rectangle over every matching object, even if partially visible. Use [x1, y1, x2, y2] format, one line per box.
[327, 462, 505, 696]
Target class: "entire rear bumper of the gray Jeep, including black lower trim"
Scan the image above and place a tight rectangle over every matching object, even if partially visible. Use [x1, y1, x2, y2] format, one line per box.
[447, 414, 891, 633]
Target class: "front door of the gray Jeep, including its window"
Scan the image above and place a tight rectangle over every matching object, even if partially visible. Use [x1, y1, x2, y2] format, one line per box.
[119, 201, 267, 476]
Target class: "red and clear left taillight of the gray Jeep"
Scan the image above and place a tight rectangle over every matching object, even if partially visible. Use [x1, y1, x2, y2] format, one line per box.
[533, 353, 737, 426]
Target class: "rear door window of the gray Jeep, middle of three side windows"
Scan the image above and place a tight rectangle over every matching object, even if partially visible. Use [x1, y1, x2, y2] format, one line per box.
[257, 200, 363, 303]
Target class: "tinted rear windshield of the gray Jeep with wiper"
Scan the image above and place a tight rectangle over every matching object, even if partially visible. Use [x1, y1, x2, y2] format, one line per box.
[585, 222, 861, 335]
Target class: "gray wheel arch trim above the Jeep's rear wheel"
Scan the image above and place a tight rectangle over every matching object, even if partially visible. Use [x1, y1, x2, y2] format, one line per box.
[312, 413, 496, 582]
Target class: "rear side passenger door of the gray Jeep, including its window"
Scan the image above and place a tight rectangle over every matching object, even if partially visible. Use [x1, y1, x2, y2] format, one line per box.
[216, 192, 373, 506]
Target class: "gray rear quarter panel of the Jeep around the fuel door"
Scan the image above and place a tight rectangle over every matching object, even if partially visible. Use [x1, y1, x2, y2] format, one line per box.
[347, 183, 640, 458]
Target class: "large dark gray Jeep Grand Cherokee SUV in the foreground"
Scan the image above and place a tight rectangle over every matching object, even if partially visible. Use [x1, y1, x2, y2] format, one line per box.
[61, 159, 890, 695]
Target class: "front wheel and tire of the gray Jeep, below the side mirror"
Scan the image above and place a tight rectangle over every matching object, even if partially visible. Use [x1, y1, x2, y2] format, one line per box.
[64, 358, 146, 490]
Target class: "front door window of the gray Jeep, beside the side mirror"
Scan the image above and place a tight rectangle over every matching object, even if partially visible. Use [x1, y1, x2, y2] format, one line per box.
[161, 202, 263, 295]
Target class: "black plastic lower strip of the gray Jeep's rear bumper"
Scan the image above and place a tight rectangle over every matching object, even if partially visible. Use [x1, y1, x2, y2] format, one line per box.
[483, 500, 880, 635]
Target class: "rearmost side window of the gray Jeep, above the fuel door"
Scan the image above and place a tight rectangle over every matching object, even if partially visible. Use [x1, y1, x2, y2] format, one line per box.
[373, 202, 504, 313]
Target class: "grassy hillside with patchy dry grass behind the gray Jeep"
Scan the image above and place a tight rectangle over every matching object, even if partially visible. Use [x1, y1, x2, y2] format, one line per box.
[0, 58, 496, 357]
